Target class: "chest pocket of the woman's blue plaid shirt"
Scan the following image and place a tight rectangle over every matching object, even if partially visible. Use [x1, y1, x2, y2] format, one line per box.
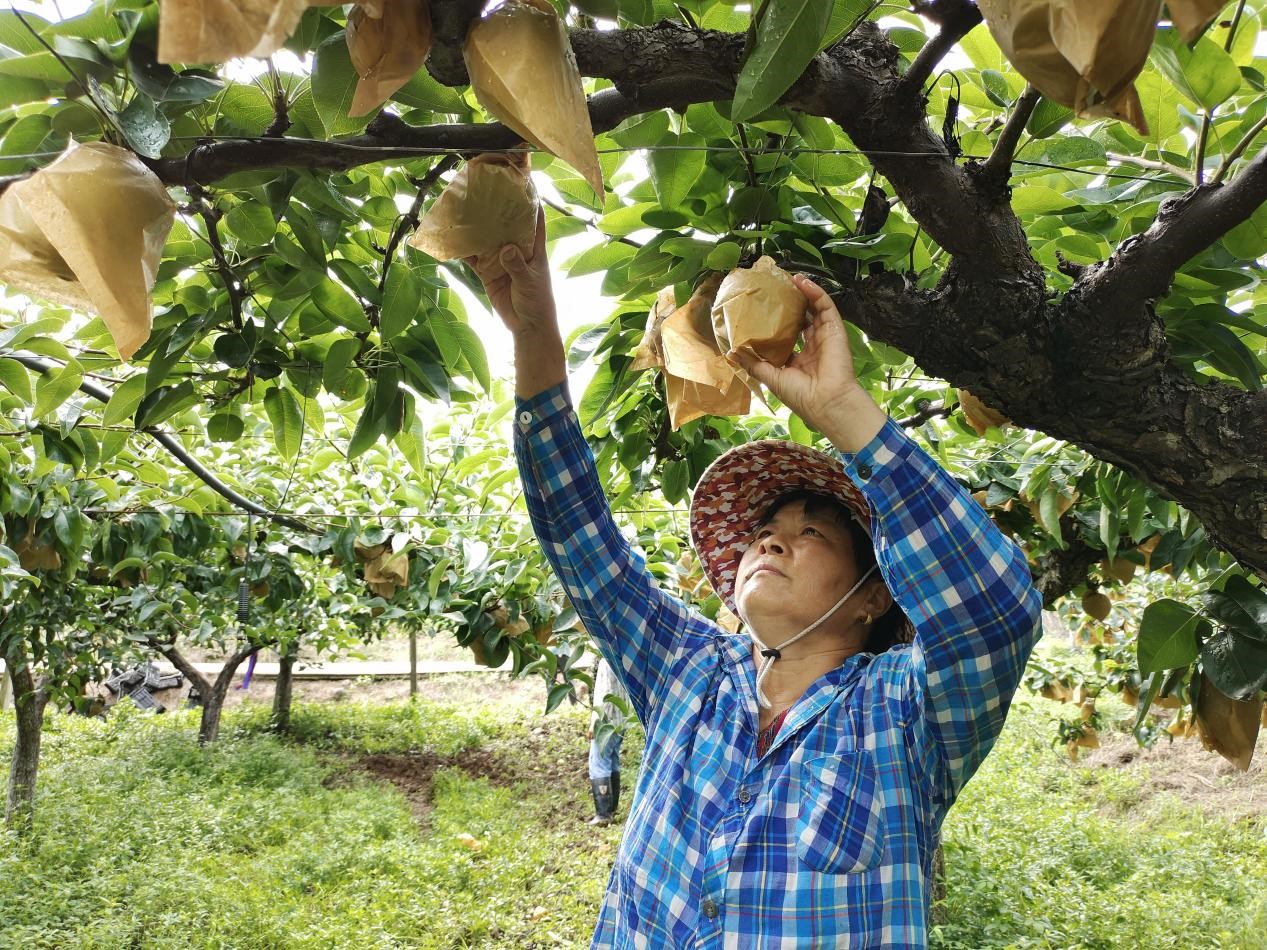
[797, 751, 884, 874]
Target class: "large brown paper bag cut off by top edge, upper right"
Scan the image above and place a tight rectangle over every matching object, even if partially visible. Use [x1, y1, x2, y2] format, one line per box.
[977, 0, 1162, 133]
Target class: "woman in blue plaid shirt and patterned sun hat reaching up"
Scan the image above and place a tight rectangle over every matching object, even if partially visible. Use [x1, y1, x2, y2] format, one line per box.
[471, 211, 1039, 947]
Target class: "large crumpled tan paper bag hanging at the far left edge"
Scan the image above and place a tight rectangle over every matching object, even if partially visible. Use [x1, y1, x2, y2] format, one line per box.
[0, 142, 176, 360]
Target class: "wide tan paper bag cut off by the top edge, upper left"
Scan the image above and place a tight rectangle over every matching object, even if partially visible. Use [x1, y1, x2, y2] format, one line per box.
[158, 0, 340, 62]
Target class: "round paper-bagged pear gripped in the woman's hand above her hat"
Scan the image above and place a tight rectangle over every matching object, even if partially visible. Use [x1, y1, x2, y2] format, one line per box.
[712, 257, 806, 366]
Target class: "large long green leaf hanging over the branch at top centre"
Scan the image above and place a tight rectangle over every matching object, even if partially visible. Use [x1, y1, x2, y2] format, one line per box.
[731, 0, 831, 122]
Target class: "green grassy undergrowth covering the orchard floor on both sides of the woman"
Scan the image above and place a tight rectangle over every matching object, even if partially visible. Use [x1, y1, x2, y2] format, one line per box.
[0, 695, 1267, 950]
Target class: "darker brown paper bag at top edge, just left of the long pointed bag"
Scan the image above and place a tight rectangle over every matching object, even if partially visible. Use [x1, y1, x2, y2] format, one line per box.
[347, 0, 431, 115]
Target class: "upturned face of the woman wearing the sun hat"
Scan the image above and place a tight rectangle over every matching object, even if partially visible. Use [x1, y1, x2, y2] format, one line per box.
[735, 500, 858, 646]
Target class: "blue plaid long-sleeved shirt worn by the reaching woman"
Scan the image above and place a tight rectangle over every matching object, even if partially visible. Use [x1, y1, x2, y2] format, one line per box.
[514, 384, 1040, 950]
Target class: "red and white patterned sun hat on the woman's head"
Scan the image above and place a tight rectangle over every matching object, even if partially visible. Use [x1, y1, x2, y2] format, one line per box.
[691, 438, 870, 611]
